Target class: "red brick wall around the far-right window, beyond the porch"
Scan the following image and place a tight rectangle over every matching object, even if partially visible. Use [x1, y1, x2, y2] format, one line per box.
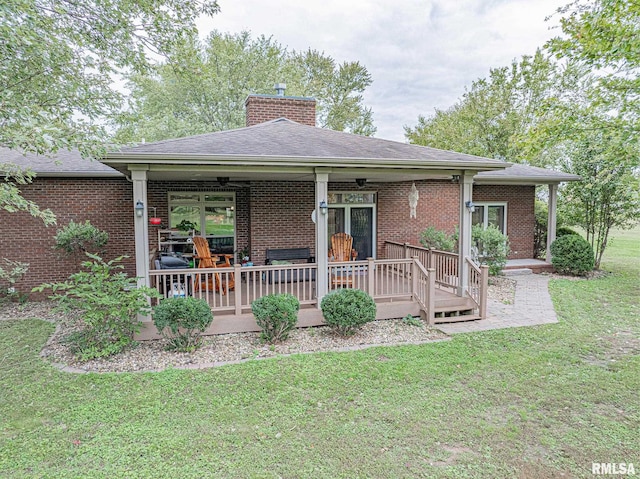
[473, 185, 536, 259]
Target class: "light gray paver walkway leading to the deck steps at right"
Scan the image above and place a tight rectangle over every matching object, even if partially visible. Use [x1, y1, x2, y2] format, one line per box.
[436, 274, 558, 334]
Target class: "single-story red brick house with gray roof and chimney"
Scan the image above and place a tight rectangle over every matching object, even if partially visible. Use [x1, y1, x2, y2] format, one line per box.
[0, 91, 578, 338]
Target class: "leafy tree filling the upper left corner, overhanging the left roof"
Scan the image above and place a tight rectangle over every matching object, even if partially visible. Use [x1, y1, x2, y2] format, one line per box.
[0, 0, 218, 156]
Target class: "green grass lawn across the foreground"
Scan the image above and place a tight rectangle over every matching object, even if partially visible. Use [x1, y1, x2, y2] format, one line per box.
[0, 230, 640, 478]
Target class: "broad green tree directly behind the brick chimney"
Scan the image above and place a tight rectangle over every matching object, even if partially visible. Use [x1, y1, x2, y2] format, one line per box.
[116, 31, 375, 142]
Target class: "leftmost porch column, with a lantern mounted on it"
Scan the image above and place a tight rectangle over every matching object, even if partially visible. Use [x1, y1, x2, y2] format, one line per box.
[129, 165, 149, 286]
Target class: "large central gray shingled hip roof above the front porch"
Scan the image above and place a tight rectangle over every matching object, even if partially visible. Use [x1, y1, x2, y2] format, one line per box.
[107, 118, 503, 166]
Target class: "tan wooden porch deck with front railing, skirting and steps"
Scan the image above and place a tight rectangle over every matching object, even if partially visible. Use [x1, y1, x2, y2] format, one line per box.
[136, 259, 479, 340]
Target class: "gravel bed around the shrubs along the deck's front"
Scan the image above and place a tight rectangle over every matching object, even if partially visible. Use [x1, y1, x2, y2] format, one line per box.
[0, 277, 516, 372]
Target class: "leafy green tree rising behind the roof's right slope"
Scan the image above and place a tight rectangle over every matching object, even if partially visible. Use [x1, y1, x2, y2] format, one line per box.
[405, 51, 559, 165]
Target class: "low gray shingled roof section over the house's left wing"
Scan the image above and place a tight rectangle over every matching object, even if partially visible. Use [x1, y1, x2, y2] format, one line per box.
[0, 147, 122, 177]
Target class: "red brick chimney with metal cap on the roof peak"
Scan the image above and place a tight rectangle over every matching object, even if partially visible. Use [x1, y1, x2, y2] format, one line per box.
[244, 83, 316, 126]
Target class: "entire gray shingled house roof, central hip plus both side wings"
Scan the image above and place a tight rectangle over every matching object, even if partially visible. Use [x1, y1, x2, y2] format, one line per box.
[0, 118, 579, 184]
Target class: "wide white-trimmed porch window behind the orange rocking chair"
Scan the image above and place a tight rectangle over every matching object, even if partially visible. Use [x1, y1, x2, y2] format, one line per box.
[169, 191, 236, 254]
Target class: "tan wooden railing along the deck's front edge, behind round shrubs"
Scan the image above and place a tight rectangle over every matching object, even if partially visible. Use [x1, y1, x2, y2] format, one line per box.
[149, 258, 435, 318]
